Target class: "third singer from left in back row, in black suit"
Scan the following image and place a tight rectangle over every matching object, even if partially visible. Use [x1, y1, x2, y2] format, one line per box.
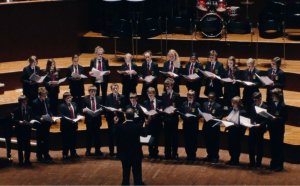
[67, 54, 84, 111]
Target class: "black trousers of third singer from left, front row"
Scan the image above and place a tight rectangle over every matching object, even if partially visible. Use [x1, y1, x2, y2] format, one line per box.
[61, 127, 77, 156]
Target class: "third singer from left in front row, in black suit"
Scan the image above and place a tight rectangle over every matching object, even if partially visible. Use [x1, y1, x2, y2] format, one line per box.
[59, 92, 79, 160]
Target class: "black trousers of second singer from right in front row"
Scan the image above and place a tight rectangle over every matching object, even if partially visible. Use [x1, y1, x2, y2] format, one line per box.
[249, 127, 266, 166]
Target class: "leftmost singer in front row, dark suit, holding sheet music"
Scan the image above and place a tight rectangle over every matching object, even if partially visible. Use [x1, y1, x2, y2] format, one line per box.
[13, 95, 32, 166]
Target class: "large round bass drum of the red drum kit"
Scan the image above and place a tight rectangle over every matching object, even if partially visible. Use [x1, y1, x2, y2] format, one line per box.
[200, 13, 224, 38]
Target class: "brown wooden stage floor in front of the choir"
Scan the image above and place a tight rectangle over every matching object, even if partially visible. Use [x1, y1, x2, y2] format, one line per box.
[0, 147, 300, 185]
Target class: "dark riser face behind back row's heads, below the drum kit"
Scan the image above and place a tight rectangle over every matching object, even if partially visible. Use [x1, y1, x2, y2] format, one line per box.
[80, 37, 300, 60]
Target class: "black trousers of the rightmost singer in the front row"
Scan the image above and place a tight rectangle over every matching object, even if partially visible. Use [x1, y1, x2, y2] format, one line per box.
[269, 119, 285, 168]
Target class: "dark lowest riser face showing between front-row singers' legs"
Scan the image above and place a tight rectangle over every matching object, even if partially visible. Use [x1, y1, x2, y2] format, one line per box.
[0, 129, 300, 164]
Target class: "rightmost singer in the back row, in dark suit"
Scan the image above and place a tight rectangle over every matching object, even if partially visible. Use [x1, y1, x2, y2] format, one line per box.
[267, 57, 285, 103]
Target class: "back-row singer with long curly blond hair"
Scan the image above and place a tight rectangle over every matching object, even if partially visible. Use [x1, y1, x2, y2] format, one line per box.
[163, 49, 182, 92]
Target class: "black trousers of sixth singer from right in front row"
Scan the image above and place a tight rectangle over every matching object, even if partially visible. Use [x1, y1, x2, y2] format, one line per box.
[164, 119, 178, 158]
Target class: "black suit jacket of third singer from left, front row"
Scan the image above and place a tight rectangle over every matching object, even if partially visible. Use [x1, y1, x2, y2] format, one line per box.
[58, 102, 78, 131]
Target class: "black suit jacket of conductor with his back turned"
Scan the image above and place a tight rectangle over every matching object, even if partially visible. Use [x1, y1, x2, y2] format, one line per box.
[116, 120, 143, 161]
